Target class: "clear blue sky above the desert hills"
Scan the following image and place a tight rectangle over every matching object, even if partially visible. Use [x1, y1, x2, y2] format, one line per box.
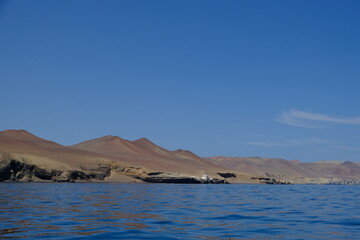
[0, 0, 360, 161]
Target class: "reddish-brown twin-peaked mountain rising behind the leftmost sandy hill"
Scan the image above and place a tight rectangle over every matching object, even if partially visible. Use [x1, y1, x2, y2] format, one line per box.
[71, 136, 227, 175]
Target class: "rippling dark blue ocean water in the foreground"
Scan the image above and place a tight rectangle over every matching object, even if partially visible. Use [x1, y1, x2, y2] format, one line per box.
[0, 183, 360, 240]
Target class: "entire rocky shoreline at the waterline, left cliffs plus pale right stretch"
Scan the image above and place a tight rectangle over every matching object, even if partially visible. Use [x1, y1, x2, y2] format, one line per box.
[0, 159, 360, 185]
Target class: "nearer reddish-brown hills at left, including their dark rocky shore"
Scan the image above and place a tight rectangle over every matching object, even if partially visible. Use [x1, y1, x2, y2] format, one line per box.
[0, 130, 240, 183]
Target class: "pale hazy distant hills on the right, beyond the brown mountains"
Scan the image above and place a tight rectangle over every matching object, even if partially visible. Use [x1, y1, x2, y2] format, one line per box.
[205, 156, 360, 184]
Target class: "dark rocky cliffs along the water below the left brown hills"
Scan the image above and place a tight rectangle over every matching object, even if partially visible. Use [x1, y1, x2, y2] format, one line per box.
[0, 159, 228, 184]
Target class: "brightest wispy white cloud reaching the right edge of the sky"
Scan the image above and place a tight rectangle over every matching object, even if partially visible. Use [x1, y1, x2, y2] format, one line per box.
[276, 109, 360, 128]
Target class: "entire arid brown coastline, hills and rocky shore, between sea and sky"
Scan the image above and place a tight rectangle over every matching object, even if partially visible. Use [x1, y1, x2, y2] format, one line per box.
[0, 130, 360, 184]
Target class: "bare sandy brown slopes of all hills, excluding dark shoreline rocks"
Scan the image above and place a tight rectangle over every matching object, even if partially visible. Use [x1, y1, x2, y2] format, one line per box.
[5, 130, 360, 183]
